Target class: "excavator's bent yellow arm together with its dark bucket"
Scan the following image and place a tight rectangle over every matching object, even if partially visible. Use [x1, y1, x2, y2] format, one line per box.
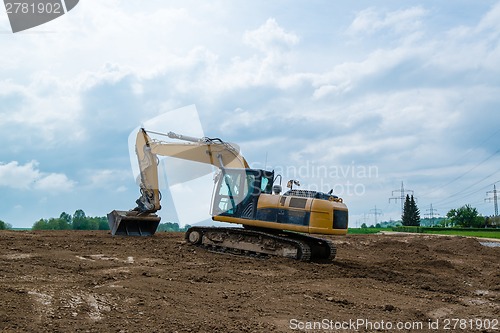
[108, 128, 249, 236]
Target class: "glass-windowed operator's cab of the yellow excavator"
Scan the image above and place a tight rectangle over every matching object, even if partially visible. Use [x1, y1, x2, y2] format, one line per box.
[211, 168, 274, 219]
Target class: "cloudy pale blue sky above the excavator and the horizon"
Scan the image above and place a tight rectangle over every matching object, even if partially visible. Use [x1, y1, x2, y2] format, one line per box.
[0, 0, 500, 227]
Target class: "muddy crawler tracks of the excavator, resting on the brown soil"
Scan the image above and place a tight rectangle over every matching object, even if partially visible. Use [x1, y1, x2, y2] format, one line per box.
[185, 227, 336, 261]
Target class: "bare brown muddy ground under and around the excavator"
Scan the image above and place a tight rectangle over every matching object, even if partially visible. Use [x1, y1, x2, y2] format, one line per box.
[0, 231, 500, 332]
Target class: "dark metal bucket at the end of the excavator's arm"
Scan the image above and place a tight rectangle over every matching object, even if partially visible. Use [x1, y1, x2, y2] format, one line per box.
[108, 210, 161, 236]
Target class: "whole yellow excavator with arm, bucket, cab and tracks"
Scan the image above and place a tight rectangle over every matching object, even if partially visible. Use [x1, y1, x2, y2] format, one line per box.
[108, 128, 348, 261]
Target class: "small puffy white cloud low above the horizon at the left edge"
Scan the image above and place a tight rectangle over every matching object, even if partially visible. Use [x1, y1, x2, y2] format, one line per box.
[0, 161, 76, 192]
